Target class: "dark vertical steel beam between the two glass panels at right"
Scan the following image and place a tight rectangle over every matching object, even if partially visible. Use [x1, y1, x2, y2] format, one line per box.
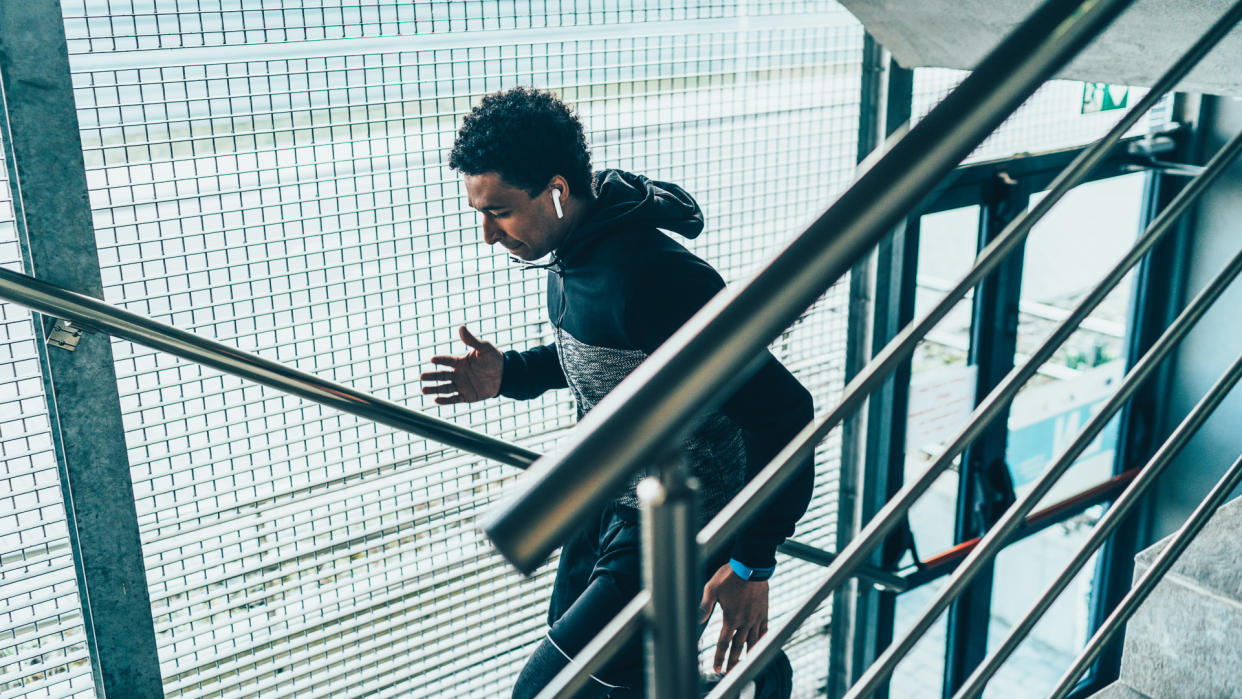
[944, 173, 1028, 697]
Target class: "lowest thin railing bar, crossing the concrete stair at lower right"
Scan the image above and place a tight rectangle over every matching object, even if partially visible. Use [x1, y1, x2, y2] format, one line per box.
[1048, 457, 1242, 699]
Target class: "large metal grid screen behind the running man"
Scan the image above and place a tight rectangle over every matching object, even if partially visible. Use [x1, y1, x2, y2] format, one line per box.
[50, 0, 862, 699]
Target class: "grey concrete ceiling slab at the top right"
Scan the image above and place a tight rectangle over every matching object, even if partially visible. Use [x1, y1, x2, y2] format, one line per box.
[842, 0, 1242, 97]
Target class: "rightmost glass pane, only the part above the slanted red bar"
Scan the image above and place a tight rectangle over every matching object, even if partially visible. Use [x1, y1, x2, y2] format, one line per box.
[1006, 174, 1144, 503]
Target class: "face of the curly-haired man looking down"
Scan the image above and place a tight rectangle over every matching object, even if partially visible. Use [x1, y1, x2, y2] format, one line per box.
[466, 173, 561, 261]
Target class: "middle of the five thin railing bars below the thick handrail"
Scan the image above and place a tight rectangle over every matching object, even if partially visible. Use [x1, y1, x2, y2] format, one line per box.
[846, 243, 1242, 699]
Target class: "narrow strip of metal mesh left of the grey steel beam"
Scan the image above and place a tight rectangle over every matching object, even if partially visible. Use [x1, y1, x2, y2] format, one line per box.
[0, 136, 94, 697]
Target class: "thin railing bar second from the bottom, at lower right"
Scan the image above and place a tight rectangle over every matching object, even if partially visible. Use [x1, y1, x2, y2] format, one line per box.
[953, 355, 1242, 699]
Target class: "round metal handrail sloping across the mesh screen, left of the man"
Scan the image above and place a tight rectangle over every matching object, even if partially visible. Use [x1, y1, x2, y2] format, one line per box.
[0, 268, 539, 468]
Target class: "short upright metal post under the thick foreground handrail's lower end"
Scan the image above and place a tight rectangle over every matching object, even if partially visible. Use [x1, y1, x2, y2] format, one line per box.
[637, 458, 699, 699]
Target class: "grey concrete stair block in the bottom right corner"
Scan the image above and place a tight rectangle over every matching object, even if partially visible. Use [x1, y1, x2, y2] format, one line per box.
[1095, 498, 1242, 699]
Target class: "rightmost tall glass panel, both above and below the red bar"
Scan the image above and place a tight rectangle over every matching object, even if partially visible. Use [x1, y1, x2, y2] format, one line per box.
[986, 174, 1144, 697]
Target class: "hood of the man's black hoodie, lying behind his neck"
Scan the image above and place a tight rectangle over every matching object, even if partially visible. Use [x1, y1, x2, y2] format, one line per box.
[556, 170, 703, 259]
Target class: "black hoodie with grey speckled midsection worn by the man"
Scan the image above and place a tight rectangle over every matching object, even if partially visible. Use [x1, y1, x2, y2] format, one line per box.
[501, 170, 814, 567]
